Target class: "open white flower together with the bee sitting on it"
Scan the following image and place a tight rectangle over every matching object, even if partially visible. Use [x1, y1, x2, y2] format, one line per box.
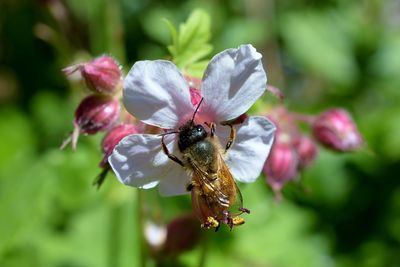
[109, 45, 275, 229]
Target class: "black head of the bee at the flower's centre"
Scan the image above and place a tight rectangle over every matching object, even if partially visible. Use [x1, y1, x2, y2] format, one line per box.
[178, 121, 207, 152]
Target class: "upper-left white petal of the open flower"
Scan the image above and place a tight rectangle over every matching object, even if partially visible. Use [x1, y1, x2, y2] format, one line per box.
[124, 60, 193, 129]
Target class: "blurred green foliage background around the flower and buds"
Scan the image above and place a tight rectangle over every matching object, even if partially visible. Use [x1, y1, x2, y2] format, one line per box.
[0, 0, 400, 267]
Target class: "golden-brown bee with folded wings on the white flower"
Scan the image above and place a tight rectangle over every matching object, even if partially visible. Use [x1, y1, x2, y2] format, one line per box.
[161, 99, 250, 231]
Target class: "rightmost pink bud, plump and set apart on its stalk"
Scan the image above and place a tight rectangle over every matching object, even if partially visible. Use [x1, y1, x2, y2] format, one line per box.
[313, 109, 363, 152]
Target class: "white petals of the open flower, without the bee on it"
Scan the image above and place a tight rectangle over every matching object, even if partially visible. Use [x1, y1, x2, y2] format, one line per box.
[109, 45, 275, 195]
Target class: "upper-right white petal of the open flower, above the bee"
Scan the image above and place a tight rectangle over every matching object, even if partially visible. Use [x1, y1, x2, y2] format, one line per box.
[199, 45, 267, 122]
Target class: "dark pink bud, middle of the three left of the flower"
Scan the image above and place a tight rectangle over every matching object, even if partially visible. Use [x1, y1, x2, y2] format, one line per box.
[61, 95, 120, 150]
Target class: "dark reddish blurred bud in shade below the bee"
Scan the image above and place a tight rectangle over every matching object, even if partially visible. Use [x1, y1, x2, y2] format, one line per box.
[163, 214, 201, 256]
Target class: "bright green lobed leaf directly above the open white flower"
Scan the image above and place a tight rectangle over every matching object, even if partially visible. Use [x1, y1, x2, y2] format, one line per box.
[166, 9, 212, 74]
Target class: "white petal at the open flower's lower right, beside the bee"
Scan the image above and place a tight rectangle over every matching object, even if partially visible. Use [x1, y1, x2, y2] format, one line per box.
[217, 117, 275, 183]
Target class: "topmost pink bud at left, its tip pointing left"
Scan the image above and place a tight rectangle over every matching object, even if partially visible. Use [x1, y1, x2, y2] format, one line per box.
[63, 56, 122, 95]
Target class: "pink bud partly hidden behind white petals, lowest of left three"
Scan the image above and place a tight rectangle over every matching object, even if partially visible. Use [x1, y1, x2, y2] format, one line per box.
[100, 123, 138, 168]
